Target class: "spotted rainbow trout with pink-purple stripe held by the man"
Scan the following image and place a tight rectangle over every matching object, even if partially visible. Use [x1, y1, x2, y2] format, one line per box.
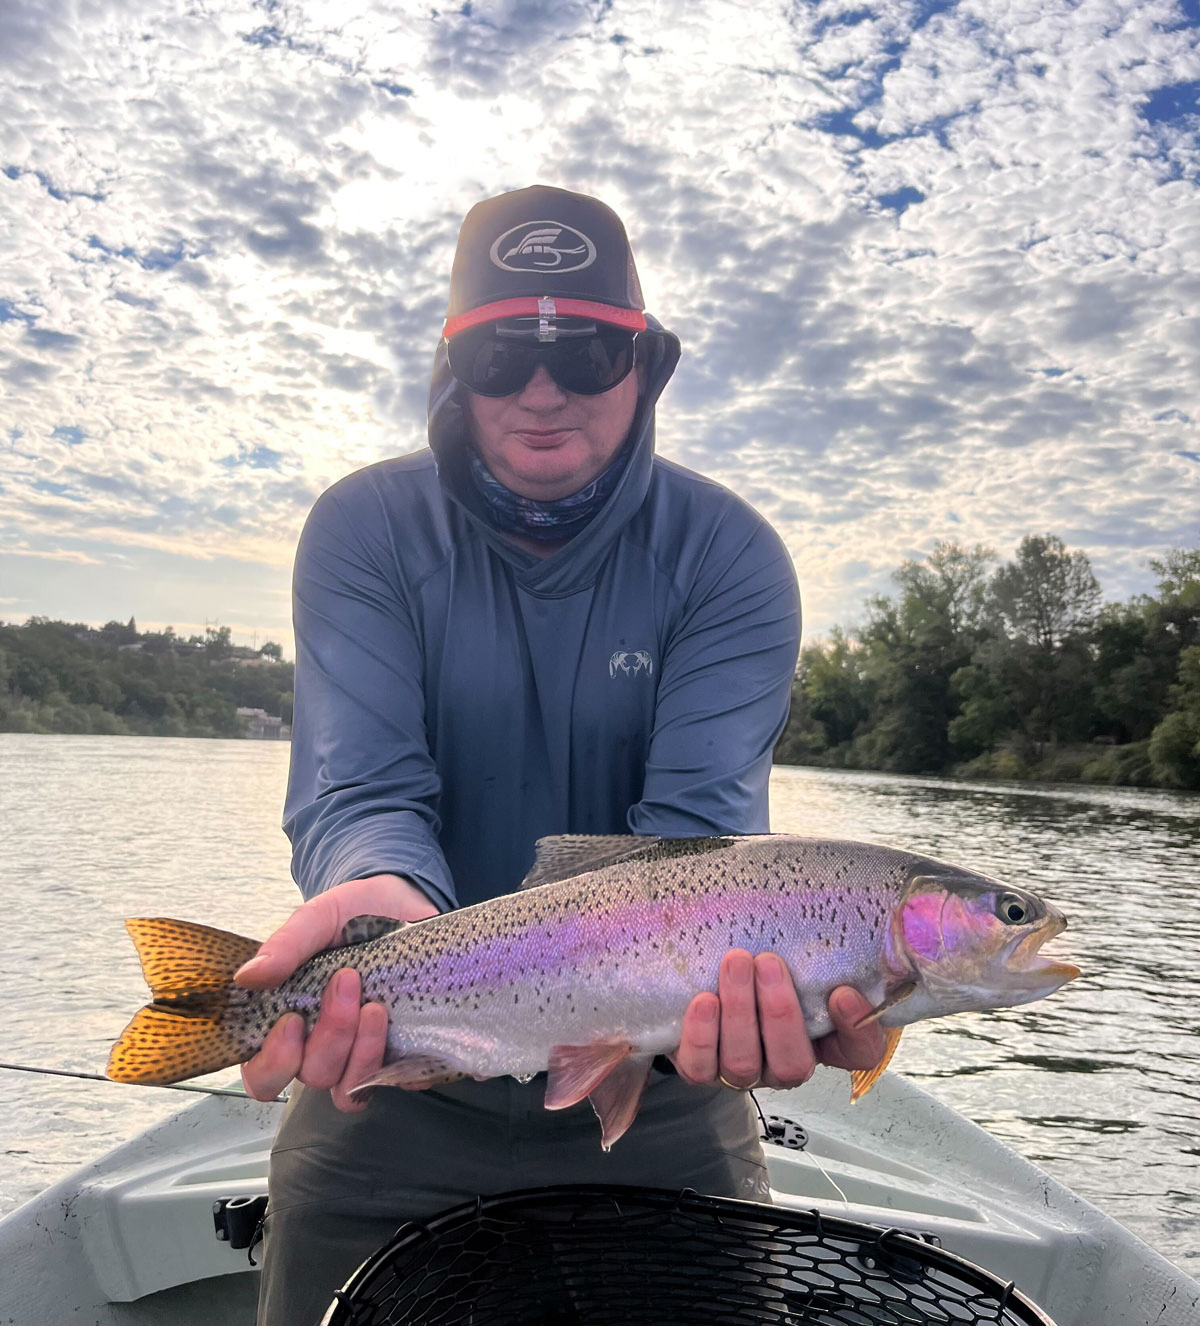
[107, 834, 1079, 1148]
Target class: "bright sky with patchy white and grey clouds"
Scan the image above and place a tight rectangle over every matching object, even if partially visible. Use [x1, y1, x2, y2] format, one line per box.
[0, 0, 1200, 648]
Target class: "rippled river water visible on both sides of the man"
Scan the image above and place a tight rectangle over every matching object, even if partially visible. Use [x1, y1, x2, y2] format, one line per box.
[0, 735, 1200, 1276]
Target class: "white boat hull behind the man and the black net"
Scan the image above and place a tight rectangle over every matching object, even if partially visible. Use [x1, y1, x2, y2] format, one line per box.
[0, 1071, 1200, 1326]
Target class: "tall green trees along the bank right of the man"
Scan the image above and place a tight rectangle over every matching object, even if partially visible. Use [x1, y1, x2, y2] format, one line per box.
[774, 534, 1200, 789]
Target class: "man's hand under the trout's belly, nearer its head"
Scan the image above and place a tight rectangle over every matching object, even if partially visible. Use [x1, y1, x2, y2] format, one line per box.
[672, 948, 883, 1087]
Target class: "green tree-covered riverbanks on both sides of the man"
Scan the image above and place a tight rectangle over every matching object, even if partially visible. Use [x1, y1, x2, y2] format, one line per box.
[0, 534, 1200, 789]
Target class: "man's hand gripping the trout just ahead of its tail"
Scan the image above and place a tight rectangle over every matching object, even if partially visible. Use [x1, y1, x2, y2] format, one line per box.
[233, 875, 438, 1114]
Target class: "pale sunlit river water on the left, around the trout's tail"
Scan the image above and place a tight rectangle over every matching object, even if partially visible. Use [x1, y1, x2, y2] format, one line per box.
[0, 735, 297, 1212]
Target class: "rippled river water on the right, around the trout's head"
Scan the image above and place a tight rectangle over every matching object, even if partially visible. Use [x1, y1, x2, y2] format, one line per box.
[772, 769, 1200, 1274]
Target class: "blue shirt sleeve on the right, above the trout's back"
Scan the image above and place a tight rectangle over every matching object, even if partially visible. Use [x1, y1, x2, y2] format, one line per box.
[629, 516, 800, 837]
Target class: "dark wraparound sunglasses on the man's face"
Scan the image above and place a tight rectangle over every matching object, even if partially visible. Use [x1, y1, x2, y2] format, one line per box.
[446, 324, 634, 396]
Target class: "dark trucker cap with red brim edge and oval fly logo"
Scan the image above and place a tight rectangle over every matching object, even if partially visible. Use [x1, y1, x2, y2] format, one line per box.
[442, 184, 646, 339]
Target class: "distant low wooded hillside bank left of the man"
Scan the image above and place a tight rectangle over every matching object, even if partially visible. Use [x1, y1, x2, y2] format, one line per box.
[0, 617, 294, 737]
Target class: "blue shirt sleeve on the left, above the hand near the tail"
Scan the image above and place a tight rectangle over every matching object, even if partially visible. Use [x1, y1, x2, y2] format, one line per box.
[284, 488, 456, 908]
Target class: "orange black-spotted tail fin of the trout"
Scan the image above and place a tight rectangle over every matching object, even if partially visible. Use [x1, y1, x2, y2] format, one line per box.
[107, 918, 259, 1085]
